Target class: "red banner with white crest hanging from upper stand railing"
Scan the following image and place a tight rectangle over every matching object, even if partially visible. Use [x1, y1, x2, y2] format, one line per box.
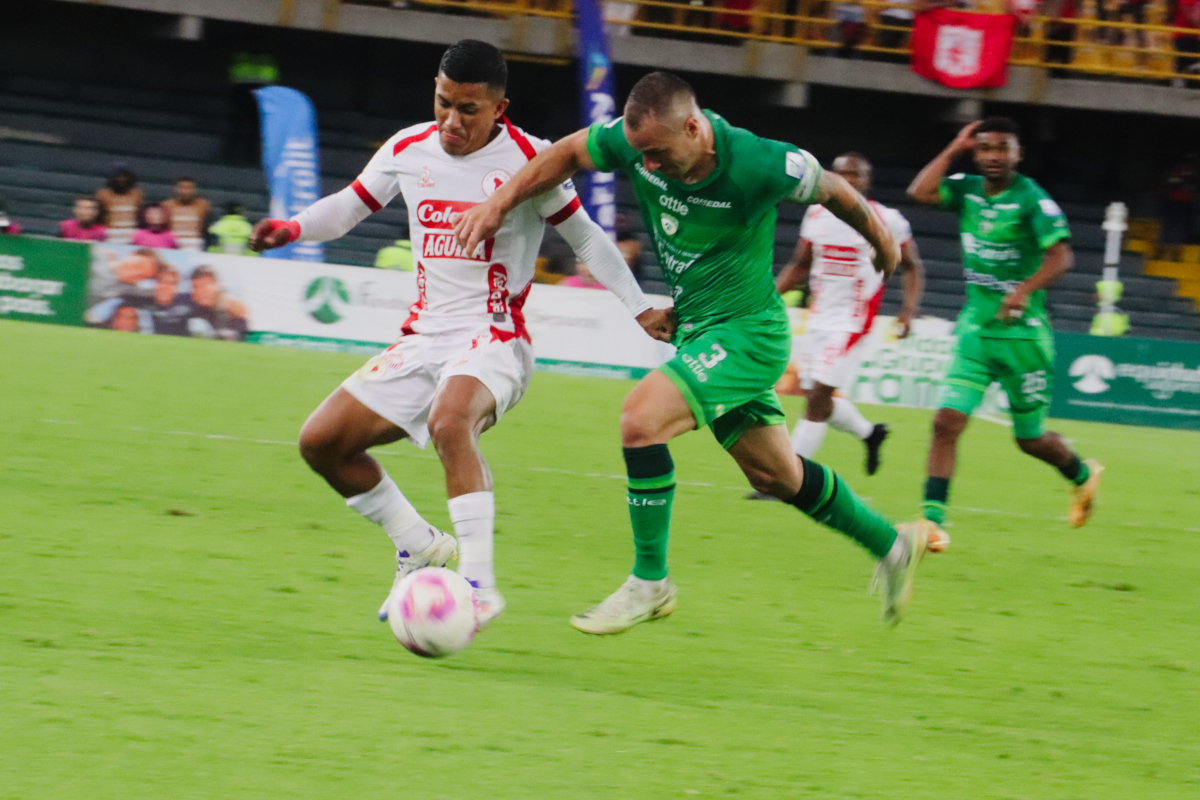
[912, 8, 1016, 89]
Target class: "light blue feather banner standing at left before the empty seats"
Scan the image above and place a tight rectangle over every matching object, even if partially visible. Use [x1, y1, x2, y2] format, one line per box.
[254, 86, 325, 263]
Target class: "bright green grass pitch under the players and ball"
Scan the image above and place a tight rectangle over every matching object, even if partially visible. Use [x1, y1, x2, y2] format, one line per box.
[0, 323, 1200, 800]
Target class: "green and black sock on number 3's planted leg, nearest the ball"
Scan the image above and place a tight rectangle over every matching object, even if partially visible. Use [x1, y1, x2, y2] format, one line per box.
[624, 445, 674, 581]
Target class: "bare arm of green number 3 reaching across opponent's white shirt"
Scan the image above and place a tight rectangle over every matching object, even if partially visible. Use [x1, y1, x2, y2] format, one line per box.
[454, 128, 595, 253]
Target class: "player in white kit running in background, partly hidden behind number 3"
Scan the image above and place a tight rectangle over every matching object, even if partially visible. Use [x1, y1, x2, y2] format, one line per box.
[775, 152, 925, 475]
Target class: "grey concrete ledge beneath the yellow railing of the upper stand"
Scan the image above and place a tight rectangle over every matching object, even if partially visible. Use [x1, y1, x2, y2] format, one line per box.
[58, 0, 1200, 118]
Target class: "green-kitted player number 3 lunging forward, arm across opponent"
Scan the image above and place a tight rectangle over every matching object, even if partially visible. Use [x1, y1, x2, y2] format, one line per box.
[455, 72, 936, 633]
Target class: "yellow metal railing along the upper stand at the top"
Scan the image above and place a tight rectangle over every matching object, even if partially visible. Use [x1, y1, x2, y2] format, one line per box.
[345, 0, 1200, 88]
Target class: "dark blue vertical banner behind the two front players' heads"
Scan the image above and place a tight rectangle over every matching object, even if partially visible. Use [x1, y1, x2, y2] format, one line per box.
[575, 0, 617, 237]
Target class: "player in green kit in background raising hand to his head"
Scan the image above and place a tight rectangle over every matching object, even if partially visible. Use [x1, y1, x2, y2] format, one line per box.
[908, 118, 1104, 537]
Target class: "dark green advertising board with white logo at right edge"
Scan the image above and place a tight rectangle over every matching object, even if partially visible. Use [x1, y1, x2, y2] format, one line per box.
[1050, 333, 1200, 428]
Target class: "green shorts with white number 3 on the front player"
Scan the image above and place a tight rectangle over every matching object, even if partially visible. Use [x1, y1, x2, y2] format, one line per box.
[659, 309, 792, 450]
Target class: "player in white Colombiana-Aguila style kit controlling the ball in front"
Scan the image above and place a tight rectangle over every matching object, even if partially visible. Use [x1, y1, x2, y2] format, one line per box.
[251, 40, 673, 627]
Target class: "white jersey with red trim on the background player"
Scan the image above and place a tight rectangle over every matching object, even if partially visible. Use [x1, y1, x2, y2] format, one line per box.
[800, 200, 912, 333]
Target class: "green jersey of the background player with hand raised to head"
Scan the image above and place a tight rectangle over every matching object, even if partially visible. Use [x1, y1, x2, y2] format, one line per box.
[938, 173, 1070, 339]
